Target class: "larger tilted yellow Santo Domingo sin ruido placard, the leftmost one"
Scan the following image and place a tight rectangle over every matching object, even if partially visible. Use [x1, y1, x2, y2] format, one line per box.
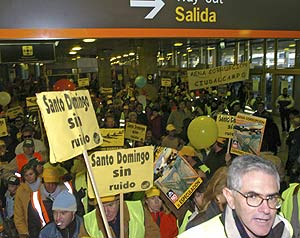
[36, 90, 102, 163]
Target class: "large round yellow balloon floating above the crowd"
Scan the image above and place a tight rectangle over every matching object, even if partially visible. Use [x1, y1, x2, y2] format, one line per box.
[187, 116, 218, 149]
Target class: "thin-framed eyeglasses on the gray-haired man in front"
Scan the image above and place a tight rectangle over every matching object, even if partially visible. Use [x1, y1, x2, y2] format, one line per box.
[233, 189, 284, 209]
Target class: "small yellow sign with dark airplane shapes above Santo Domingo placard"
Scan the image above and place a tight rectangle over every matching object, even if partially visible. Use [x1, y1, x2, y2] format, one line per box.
[100, 128, 124, 147]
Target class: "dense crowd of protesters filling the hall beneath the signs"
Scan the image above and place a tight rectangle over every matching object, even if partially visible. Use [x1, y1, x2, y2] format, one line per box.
[0, 80, 300, 238]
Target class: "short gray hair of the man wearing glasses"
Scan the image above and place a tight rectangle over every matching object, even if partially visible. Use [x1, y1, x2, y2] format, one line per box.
[227, 155, 280, 190]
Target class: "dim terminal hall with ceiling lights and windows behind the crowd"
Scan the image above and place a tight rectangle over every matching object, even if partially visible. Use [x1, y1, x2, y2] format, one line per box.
[0, 38, 300, 165]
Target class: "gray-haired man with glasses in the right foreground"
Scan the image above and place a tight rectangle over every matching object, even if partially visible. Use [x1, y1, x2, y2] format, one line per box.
[179, 155, 293, 238]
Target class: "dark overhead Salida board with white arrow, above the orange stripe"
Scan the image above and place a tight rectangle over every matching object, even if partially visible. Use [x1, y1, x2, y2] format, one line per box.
[0, 0, 300, 31]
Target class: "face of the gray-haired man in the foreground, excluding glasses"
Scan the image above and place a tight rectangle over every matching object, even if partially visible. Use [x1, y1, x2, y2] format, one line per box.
[223, 171, 279, 238]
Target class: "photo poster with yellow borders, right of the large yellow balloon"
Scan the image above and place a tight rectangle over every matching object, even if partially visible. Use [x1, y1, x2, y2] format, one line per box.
[230, 113, 266, 155]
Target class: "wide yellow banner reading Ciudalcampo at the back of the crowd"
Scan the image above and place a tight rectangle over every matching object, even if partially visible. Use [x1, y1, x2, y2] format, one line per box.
[187, 61, 250, 90]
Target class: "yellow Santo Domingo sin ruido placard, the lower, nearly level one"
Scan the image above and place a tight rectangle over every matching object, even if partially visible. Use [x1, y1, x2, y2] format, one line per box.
[88, 146, 154, 197]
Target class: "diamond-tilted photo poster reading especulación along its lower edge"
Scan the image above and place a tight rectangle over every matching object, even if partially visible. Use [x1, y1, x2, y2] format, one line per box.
[154, 147, 202, 209]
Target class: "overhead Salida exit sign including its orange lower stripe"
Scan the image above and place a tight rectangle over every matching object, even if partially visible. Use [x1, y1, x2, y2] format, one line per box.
[0, 0, 300, 39]
